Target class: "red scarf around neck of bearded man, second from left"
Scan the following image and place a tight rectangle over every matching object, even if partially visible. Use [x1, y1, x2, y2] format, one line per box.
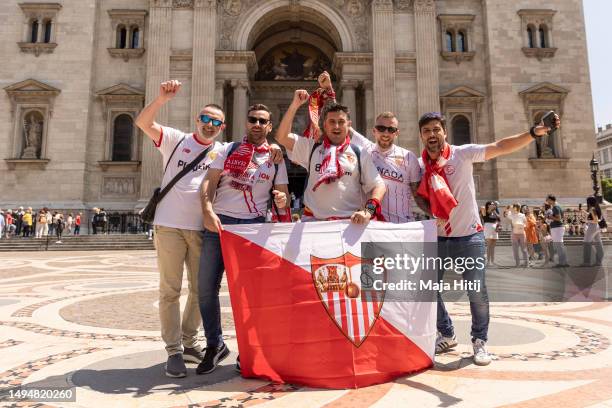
[223, 136, 270, 191]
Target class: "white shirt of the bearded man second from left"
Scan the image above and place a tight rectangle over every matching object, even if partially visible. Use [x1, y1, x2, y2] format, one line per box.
[210, 143, 289, 220]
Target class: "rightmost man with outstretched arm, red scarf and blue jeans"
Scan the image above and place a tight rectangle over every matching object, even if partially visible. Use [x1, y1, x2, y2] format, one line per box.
[418, 113, 560, 365]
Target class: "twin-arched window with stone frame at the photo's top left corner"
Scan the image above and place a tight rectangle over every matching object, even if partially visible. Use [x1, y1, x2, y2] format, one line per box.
[17, 3, 62, 57]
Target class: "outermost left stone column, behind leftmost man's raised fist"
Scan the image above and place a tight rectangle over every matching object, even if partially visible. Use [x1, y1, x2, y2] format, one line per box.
[140, 0, 172, 201]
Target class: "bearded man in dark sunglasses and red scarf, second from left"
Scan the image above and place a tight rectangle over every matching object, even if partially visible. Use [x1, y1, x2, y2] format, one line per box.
[196, 104, 291, 374]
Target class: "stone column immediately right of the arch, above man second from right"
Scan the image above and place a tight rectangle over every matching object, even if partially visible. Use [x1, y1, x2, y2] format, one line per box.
[372, 0, 395, 113]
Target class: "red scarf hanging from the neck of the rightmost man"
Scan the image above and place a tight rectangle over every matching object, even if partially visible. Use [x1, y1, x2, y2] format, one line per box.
[417, 143, 457, 235]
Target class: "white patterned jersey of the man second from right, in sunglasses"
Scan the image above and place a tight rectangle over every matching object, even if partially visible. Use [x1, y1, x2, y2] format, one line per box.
[352, 131, 421, 223]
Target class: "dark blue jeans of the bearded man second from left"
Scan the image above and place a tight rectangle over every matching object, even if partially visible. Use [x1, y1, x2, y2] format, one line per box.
[198, 214, 265, 347]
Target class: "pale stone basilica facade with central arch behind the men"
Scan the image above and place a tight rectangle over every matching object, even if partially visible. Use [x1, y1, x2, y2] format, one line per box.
[0, 0, 595, 211]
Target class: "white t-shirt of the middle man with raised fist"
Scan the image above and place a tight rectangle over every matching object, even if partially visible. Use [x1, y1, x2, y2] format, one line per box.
[287, 134, 384, 220]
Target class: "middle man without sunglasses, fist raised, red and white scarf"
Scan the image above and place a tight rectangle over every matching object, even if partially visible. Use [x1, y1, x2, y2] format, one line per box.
[276, 90, 386, 224]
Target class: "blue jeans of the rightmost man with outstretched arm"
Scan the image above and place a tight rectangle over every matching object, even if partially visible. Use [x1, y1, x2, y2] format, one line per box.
[437, 232, 489, 341]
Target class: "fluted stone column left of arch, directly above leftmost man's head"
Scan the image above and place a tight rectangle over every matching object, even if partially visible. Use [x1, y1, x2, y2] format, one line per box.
[191, 0, 217, 127]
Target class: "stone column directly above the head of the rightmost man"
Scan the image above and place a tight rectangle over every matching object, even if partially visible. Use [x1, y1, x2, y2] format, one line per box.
[414, 0, 440, 116]
